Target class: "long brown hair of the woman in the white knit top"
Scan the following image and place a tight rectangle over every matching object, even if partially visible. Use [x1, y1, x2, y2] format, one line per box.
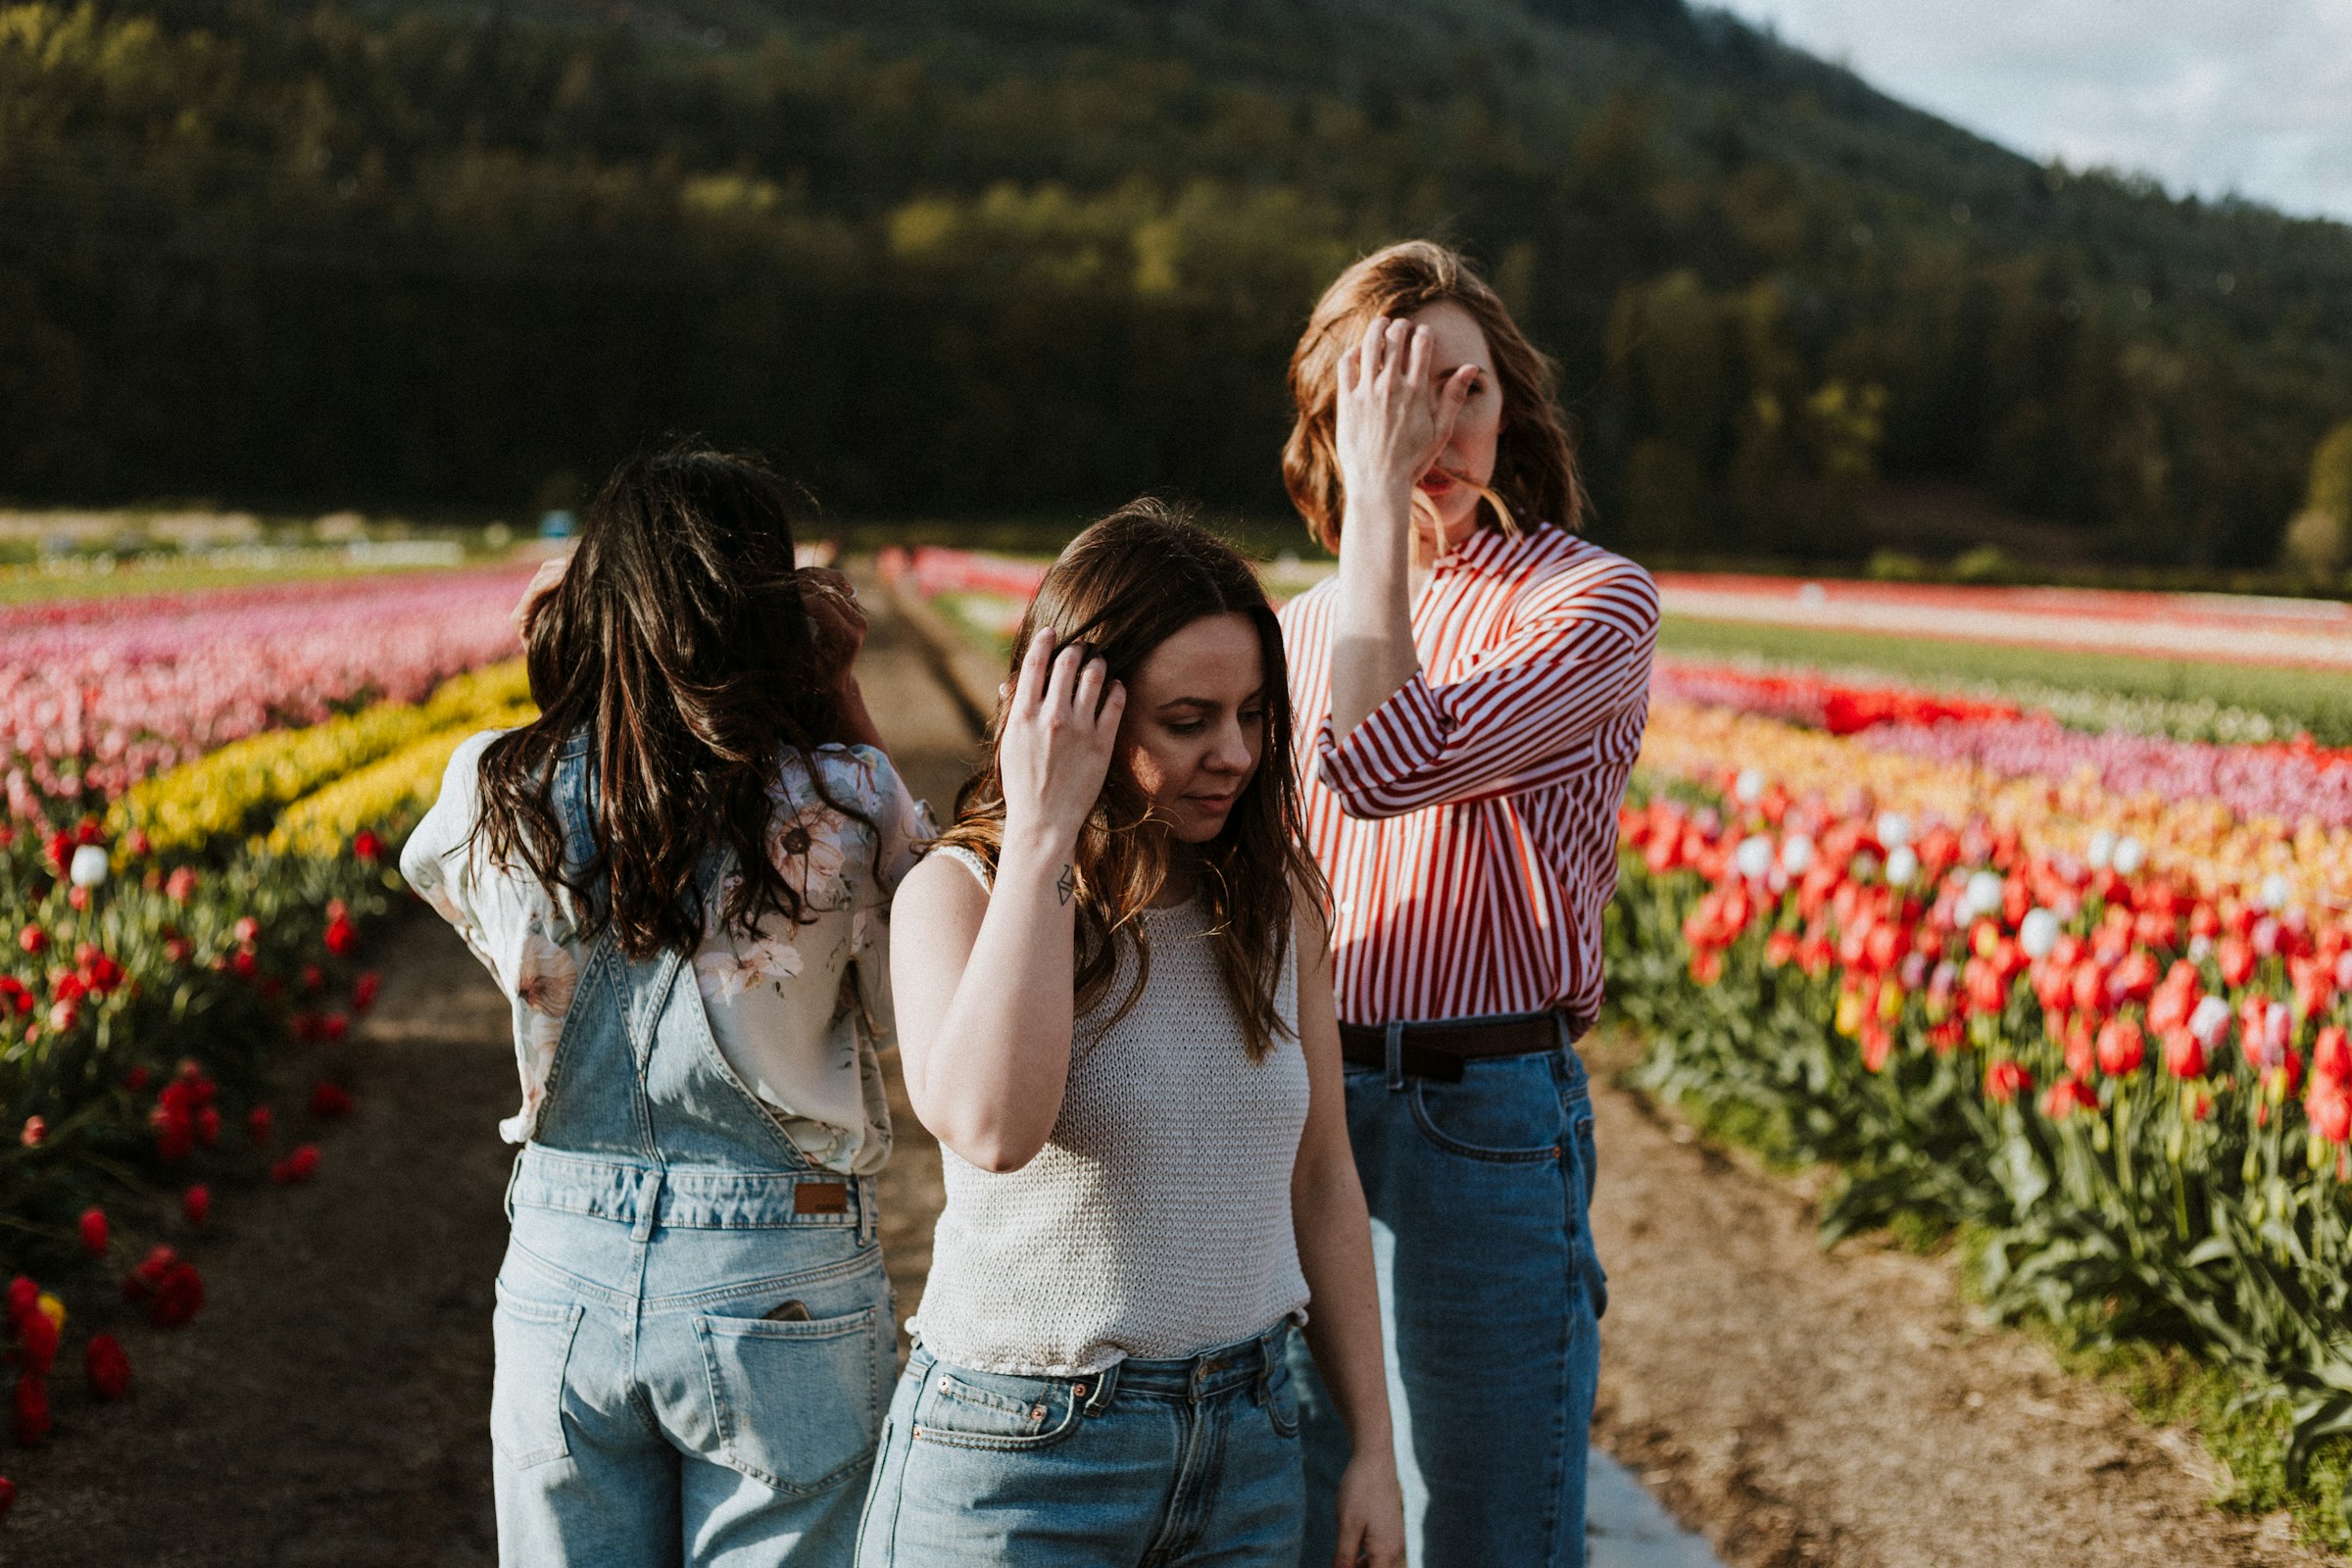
[941, 499, 1322, 1060]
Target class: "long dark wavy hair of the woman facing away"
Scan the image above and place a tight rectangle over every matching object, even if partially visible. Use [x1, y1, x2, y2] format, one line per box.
[475, 447, 865, 959]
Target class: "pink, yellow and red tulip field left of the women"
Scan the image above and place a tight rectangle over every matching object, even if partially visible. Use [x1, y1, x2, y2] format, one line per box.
[0, 569, 531, 1511]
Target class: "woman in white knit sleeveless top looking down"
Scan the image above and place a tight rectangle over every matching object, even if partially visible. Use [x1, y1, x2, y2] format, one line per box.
[858, 501, 1404, 1568]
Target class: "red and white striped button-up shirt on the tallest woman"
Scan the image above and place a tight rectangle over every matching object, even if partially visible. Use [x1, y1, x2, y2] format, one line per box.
[1282, 526, 1658, 1030]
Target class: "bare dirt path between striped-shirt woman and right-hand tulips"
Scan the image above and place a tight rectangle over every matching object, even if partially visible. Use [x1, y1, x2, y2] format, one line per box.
[1592, 1029, 2342, 1568]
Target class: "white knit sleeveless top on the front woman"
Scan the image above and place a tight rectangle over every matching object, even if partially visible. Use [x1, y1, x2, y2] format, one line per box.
[915, 849, 1307, 1378]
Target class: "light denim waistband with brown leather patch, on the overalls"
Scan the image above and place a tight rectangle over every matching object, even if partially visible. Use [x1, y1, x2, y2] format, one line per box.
[506, 1143, 872, 1230]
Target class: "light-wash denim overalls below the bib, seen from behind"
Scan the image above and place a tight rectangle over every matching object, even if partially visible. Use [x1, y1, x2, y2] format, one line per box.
[489, 1148, 896, 1568]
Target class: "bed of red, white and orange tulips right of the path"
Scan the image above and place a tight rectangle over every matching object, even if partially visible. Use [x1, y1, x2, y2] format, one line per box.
[1609, 679, 2352, 1523]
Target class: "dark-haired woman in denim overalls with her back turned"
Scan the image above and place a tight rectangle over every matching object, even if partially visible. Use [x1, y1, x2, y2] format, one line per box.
[402, 454, 919, 1568]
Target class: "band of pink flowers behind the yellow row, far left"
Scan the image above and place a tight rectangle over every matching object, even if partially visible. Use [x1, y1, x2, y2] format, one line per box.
[0, 566, 527, 827]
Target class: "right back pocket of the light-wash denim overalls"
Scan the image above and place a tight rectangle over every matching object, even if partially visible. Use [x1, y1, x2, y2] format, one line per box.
[694, 1307, 884, 1495]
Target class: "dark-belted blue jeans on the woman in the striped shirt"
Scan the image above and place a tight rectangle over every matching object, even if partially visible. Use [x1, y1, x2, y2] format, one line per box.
[1292, 1046, 1609, 1568]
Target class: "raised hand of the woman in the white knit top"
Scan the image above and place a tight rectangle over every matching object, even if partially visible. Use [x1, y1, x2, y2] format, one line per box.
[998, 630, 1127, 860]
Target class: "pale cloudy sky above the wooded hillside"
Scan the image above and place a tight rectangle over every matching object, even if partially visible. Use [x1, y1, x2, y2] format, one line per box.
[1717, 0, 2352, 220]
